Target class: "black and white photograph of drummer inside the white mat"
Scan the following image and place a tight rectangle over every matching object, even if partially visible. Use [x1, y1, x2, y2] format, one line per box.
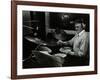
[22, 11, 90, 69]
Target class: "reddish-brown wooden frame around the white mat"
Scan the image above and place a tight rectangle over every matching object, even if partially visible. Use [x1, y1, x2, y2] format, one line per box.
[11, 1, 97, 79]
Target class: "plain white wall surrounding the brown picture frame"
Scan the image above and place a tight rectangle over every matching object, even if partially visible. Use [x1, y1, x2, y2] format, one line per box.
[0, 0, 100, 80]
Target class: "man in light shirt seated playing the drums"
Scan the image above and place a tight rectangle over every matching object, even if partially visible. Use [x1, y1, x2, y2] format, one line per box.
[57, 20, 89, 65]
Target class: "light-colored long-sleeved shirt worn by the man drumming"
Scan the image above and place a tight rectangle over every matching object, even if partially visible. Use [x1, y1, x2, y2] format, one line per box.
[68, 30, 89, 56]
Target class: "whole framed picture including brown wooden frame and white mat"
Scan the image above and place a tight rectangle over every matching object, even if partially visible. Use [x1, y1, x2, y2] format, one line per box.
[11, 1, 97, 79]
